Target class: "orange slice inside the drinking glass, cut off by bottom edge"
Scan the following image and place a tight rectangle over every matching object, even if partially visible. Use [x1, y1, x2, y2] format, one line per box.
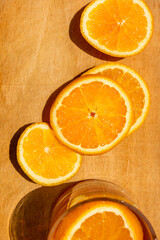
[53, 201, 143, 240]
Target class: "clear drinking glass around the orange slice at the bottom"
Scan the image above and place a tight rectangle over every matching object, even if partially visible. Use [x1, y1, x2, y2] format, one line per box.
[47, 180, 157, 240]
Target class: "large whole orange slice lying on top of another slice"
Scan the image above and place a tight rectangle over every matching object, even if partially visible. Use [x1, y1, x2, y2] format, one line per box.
[50, 75, 133, 155]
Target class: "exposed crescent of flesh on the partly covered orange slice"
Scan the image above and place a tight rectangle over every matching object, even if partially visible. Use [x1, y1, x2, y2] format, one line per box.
[98, 68, 145, 124]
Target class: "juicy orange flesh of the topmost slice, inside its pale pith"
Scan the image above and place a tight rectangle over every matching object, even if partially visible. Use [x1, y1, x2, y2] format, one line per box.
[86, 0, 147, 52]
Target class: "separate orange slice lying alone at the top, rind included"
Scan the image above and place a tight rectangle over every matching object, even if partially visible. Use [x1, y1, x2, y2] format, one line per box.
[80, 0, 153, 57]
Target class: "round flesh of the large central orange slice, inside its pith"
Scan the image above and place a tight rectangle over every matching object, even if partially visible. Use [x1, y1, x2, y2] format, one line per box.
[56, 81, 127, 148]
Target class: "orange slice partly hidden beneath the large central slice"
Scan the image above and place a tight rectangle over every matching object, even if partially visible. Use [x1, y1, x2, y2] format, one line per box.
[84, 63, 150, 134]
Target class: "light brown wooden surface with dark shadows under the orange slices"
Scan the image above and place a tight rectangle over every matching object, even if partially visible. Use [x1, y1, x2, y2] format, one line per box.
[0, 0, 160, 240]
